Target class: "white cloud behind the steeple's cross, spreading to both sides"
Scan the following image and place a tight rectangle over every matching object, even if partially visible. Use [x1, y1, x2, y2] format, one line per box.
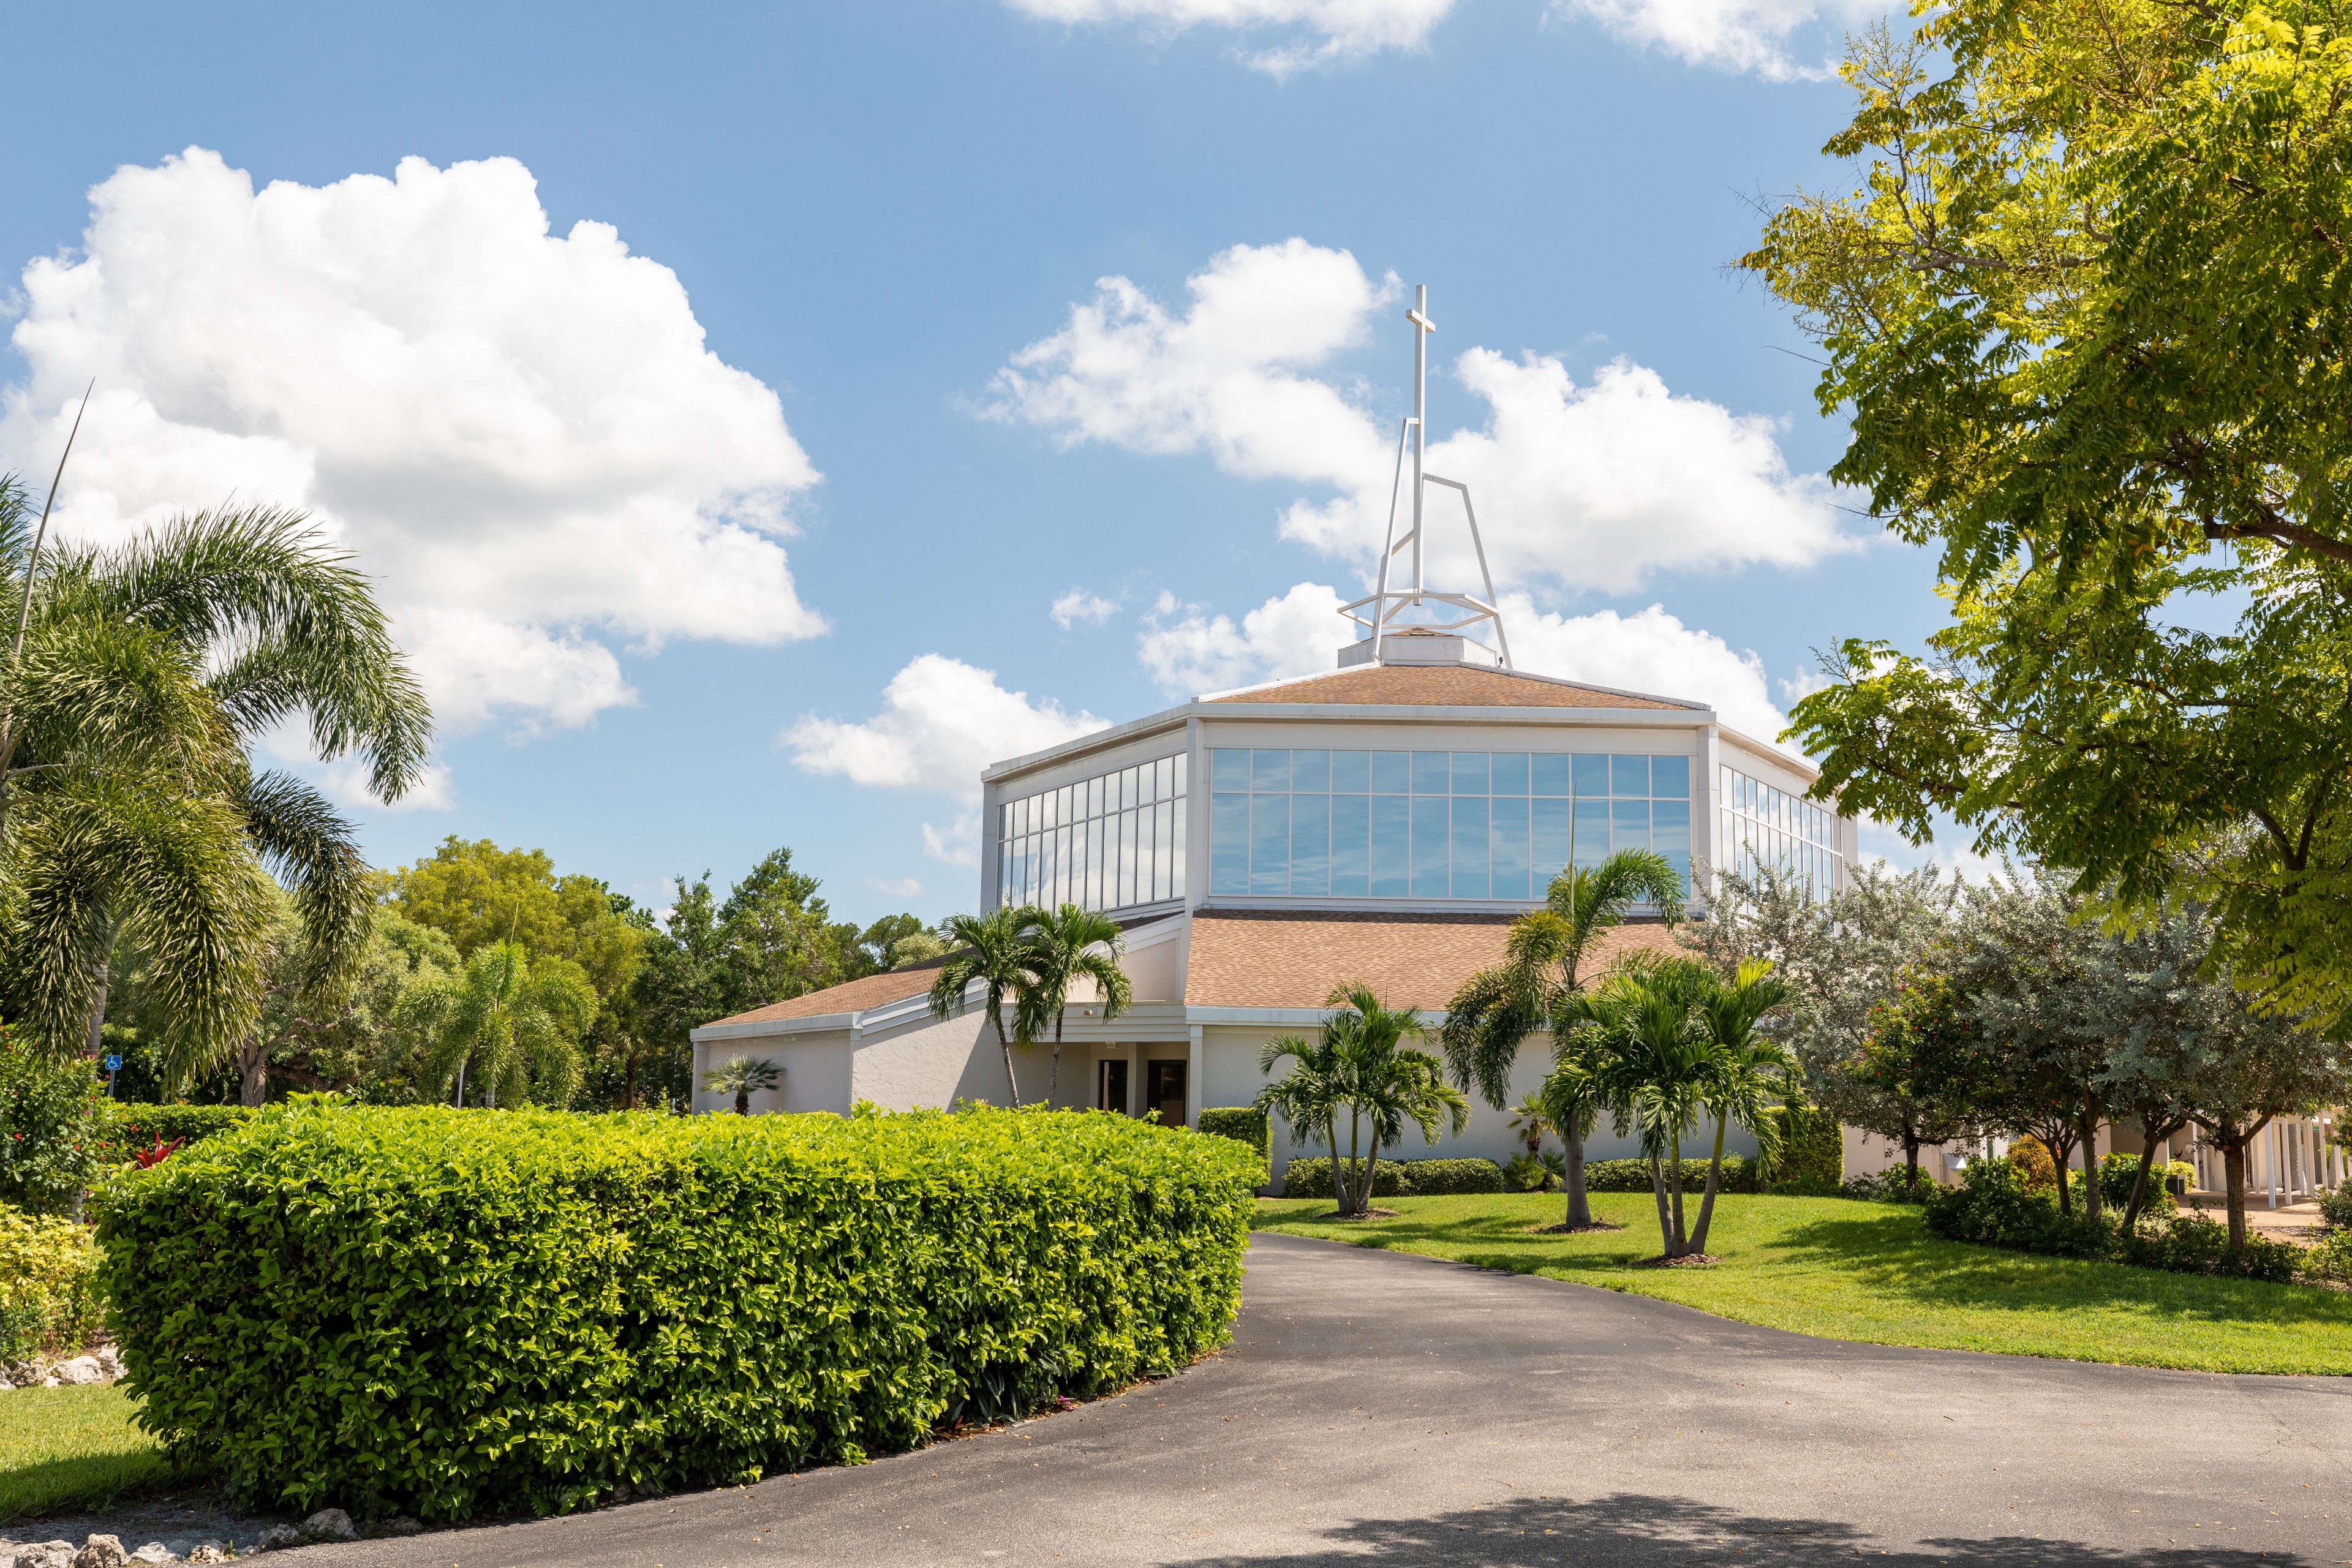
[983, 239, 1853, 592]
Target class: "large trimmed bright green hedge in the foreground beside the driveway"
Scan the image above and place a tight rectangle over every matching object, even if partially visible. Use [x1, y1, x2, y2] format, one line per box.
[96, 1102, 1256, 1518]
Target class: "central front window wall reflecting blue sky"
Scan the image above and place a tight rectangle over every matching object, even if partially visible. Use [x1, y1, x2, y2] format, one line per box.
[1209, 748, 1691, 903]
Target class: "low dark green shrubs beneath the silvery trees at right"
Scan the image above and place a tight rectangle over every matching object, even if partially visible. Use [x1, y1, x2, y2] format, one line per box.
[1926, 1159, 2305, 1284]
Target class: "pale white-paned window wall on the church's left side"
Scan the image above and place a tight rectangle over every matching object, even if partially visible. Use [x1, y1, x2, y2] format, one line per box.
[997, 755, 1185, 910]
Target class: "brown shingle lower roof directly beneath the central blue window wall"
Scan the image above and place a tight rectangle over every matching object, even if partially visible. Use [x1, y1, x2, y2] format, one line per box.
[1183, 910, 1679, 1009]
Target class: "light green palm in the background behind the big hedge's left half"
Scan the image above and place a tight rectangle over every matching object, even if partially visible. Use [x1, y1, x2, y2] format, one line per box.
[393, 943, 597, 1107]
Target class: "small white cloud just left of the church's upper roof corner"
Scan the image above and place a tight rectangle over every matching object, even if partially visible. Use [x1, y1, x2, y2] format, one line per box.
[776, 654, 1110, 804]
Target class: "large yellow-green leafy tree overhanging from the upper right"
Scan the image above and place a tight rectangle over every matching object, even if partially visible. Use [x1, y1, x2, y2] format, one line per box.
[1745, 0, 2352, 1023]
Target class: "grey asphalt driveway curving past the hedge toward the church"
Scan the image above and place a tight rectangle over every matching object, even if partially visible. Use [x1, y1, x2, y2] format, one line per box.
[303, 1237, 2352, 1568]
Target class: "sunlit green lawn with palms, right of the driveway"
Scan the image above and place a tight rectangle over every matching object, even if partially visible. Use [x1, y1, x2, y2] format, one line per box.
[1254, 1192, 2352, 1373]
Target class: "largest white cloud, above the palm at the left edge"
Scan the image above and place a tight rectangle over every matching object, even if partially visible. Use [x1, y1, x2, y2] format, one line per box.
[0, 148, 826, 731]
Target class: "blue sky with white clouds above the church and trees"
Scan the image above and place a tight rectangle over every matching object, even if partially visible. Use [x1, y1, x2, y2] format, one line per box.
[0, 0, 1940, 919]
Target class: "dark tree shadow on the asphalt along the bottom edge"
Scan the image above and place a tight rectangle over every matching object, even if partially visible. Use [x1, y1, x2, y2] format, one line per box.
[1188, 1493, 2295, 1568]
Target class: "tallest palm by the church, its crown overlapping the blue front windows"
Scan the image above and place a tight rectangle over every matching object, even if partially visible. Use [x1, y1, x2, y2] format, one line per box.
[1437, 849, 1682, 1227]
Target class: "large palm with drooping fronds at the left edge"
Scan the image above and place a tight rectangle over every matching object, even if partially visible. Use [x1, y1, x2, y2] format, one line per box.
[0, 480, 431, 1102]
